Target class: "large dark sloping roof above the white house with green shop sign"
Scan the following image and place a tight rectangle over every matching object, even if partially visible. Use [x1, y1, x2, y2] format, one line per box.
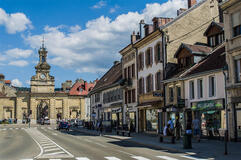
[182, 43, 226, 77]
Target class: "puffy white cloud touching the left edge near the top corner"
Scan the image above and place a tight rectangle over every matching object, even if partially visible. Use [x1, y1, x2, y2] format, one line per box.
[0, 8, 32, 34]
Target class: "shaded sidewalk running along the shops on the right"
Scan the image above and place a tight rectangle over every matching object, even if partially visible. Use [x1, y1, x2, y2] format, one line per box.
[73, 128, 241, 160]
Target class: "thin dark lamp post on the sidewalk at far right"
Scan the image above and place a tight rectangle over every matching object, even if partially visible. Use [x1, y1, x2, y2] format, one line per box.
[223, 64, 228, 155]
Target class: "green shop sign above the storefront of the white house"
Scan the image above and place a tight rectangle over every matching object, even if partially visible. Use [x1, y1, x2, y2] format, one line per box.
[192, 101, 223, 110]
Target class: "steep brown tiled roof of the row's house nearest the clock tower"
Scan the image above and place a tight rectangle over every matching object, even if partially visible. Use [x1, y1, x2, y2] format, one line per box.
[92, 63, 122, 91]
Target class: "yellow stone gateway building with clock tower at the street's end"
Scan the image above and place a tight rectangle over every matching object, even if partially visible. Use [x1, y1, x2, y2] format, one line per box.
[0, 45, 94, 123]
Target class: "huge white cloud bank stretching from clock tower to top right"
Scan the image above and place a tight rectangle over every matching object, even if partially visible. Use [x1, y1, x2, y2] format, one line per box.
[24, 0, 186, 73]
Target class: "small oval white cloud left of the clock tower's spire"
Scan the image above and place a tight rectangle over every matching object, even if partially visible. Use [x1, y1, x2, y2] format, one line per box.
[5, 48, 33, 58]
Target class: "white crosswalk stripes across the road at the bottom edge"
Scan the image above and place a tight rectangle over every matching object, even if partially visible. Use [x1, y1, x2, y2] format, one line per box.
[21, 155, 213, 160]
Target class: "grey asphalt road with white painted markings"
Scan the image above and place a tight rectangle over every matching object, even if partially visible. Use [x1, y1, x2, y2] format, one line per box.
[0, 125, 211, 160]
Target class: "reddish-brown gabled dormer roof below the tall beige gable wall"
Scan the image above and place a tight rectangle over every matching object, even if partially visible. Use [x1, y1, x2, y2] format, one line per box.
[174, 43, 212, 58]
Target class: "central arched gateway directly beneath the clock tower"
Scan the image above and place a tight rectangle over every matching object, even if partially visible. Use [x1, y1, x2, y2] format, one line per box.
[37, 101, 49, 120]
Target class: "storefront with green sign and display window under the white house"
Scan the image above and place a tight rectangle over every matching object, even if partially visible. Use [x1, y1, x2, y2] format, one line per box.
[191, 99, 225, 138]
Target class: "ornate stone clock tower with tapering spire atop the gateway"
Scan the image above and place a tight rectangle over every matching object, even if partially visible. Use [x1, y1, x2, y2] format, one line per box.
[30, 42, 54, 93]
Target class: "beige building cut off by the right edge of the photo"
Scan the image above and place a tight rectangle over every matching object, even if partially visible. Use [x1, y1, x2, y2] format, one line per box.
[221, 0, 241, 141]
